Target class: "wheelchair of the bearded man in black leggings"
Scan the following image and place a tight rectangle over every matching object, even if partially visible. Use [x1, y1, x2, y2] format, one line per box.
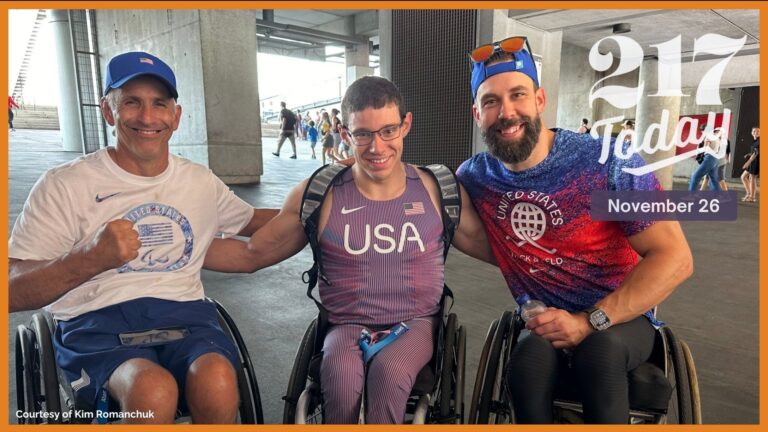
[469, 311, 701, 424]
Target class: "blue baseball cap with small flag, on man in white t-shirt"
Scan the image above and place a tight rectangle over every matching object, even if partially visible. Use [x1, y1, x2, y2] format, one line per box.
[104, 51, 179, 99]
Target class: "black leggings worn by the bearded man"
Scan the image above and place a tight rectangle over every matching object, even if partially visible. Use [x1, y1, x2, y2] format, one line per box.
[505, 316, 655, 424]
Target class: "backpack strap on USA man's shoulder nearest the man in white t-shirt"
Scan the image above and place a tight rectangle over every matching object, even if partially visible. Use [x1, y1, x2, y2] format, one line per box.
[300, 164, 349, 330]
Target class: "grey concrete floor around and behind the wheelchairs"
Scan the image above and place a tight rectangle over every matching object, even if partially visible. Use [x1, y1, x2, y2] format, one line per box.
[8, 130, 759, 424]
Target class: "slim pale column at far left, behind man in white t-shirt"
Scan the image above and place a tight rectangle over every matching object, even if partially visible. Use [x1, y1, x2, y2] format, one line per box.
[48, 9, 84, 152]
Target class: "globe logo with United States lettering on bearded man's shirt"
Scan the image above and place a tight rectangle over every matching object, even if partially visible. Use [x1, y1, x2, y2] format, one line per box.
[496, 191, 563, 254]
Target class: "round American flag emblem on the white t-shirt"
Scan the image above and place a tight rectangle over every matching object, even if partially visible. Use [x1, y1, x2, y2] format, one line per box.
[117, 203, 194, 273]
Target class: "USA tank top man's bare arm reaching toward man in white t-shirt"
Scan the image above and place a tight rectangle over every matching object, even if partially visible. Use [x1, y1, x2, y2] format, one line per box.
[203, 181, 307, 273]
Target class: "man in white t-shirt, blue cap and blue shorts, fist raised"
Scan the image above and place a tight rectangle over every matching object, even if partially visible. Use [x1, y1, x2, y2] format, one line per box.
[8, 52, 276, 423]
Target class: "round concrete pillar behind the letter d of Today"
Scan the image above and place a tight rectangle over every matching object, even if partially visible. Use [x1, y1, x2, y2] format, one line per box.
[633, 59, 680, 190]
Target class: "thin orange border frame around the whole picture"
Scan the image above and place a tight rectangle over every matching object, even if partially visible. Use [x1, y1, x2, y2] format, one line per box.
[0, 1, 768, 432]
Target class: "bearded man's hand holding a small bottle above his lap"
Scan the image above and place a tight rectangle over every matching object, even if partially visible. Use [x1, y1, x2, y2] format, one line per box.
[525, 308, 594, 349]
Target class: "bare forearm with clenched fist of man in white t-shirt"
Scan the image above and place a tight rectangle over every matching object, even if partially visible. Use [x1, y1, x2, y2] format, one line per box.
[8, 219, 141, 312]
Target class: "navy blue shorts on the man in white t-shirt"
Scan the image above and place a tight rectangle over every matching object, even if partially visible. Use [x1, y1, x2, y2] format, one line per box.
[53, 298, 240, 407]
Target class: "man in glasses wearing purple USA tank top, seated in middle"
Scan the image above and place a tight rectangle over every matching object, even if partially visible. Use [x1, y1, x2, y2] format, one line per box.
[205, 76, 494, 423]
